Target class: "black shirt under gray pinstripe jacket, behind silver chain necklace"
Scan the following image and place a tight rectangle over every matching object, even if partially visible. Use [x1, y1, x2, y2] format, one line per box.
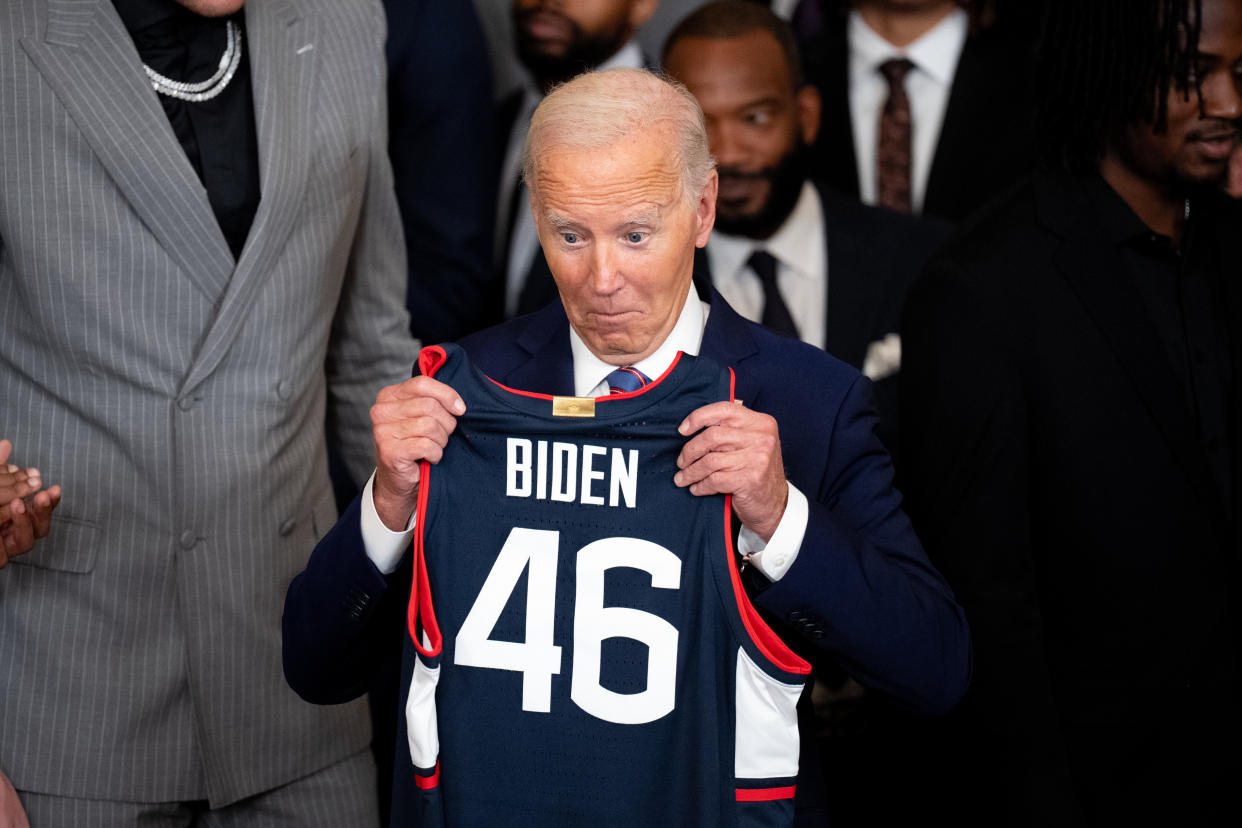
[112, 0, 260, 258]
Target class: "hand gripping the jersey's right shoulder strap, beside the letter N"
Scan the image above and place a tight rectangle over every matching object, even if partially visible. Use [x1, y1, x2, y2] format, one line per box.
[673, 402, 789, 542]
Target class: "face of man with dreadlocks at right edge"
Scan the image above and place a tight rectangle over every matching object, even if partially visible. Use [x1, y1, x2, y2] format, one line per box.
[1119, 0, 1242, 191]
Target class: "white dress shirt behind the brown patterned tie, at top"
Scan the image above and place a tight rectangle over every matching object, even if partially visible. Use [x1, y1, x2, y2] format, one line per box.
[846, 9, 968, 212]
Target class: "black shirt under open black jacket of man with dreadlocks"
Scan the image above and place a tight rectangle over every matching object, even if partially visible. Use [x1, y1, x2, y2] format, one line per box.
[1087, 178, 1232, 503]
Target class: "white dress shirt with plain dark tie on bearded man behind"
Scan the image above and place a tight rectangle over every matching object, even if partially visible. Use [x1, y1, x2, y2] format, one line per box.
[707, 181, 828, 348]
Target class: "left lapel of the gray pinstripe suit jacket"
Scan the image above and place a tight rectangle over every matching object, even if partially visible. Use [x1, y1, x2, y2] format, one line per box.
[21, 0, 232, 300]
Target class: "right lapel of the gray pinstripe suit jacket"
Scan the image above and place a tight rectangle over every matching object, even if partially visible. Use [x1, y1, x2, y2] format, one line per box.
[181, 0, 317, 394]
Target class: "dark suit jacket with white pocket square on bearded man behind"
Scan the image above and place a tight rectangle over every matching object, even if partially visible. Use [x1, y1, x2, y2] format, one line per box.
[694, 187, 950, 466]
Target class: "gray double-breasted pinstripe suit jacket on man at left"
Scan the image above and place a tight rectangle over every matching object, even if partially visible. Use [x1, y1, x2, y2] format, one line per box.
[0, 0, 415, 806]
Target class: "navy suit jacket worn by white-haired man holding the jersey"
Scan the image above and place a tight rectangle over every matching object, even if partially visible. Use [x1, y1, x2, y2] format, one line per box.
[284, 293, 970, 816]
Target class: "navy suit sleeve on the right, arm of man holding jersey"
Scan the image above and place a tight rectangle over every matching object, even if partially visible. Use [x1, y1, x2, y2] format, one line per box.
[755, 377, 971, 714]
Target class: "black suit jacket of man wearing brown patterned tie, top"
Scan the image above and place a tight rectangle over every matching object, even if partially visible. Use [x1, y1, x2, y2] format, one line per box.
[804, 15, 1036, 221]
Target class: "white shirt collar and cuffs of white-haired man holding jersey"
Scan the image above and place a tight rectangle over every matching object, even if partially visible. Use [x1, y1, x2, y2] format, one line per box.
[361, 287, 810, 581]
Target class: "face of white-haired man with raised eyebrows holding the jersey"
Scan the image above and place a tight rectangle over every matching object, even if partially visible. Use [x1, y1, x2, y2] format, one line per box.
[530, 129, 715, 365]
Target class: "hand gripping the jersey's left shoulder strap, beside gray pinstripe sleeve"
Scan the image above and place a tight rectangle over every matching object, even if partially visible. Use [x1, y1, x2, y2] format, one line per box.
[371, 376, 466, 531]
